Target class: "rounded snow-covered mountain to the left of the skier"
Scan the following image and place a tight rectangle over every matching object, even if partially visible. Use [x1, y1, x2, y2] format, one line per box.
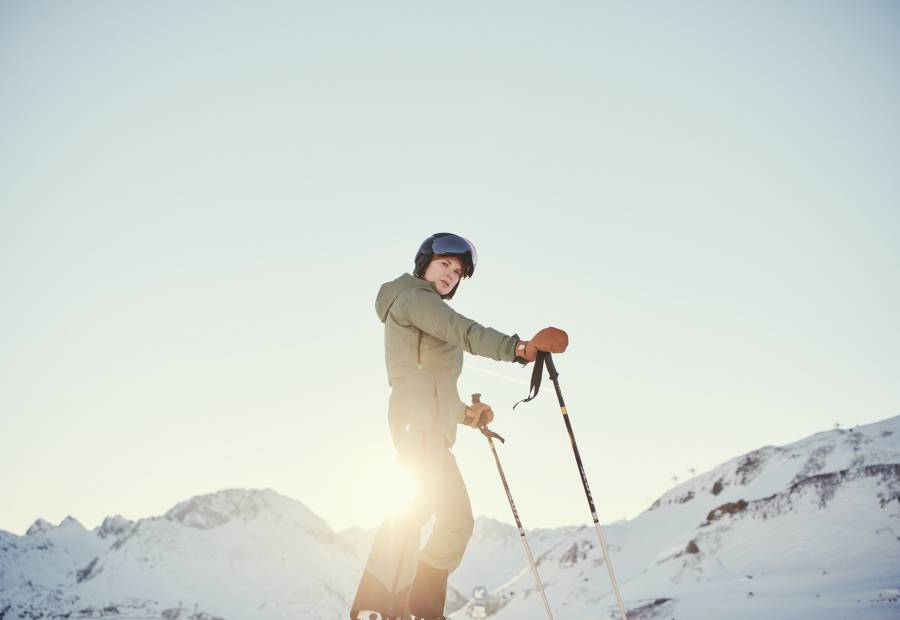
[0, 490, 360, 619]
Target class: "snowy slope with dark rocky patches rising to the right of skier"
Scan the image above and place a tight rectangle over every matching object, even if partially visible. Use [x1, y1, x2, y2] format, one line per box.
[452, 417, 900, 620]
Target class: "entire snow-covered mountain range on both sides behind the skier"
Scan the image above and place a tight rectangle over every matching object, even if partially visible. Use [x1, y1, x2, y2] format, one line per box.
[0, 416, 900, 620]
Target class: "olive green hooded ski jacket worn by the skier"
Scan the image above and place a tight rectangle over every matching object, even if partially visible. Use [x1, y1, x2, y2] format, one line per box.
[375, 273, 519, 453]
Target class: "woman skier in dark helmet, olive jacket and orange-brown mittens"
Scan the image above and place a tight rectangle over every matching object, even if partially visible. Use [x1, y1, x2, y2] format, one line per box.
[350, 233, 568, 620]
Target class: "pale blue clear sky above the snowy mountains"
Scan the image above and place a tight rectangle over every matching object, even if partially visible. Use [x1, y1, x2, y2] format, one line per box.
[0, 2, 900, 533]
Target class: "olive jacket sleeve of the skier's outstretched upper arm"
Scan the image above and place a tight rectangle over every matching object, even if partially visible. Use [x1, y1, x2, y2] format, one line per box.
[397, 288, 519, 362]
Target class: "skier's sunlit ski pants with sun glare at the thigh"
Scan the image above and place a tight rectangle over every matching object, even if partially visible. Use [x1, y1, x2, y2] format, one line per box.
[354, 431, 475, 613]
